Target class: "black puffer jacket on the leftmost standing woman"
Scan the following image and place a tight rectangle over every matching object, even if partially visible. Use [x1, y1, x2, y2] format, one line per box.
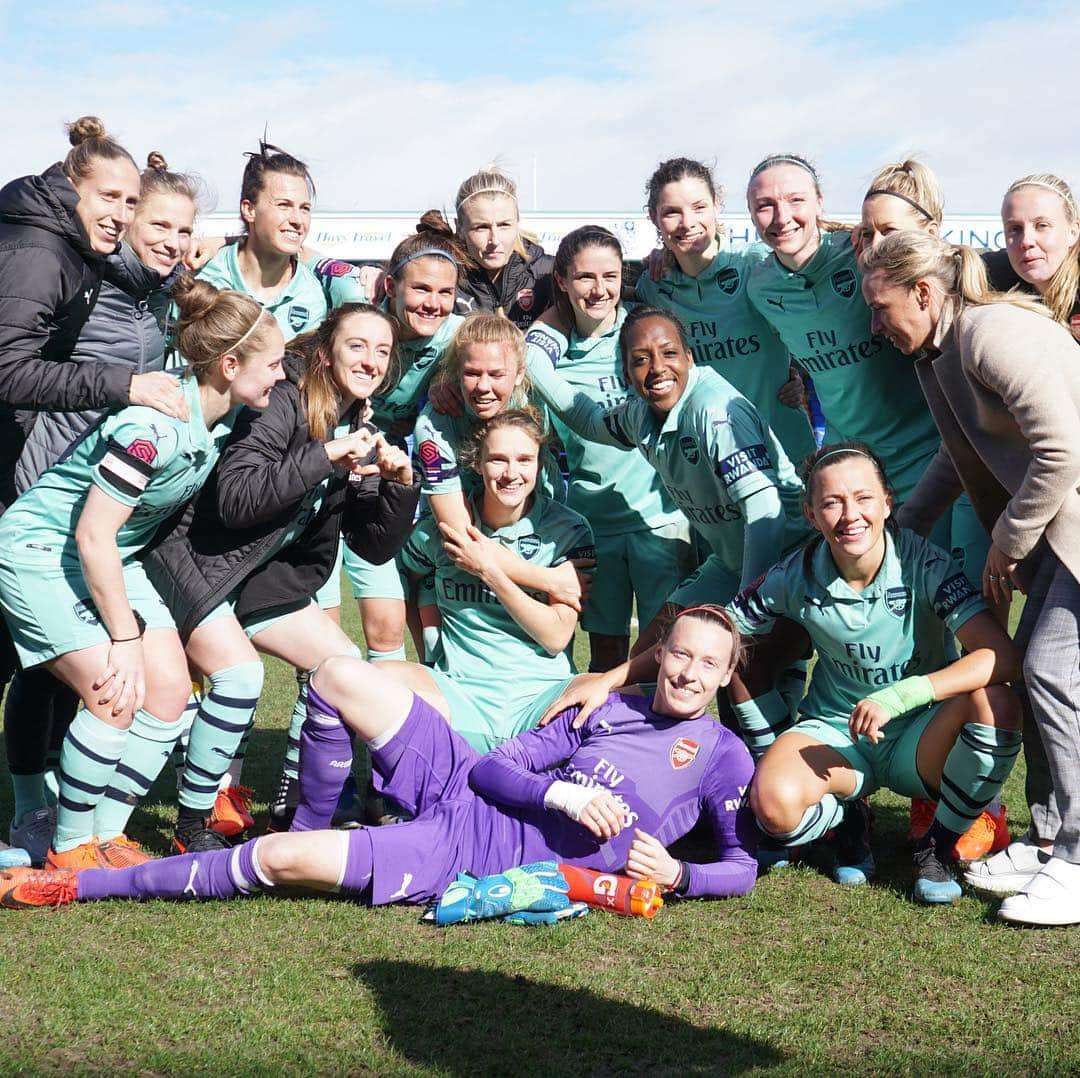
[0, 164, 132, 510]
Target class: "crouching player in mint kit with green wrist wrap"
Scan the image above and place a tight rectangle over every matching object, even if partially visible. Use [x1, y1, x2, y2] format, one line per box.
[733, 442, 1021, 903]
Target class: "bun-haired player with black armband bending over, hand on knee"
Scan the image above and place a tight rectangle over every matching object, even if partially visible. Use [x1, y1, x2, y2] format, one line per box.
[0, 277, 284, 867]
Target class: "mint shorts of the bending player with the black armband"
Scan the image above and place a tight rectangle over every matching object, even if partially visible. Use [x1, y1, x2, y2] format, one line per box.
[0, 561, 176, 669]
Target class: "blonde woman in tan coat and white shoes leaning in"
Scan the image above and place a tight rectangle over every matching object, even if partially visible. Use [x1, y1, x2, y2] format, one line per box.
[862, 232, 1080, 925]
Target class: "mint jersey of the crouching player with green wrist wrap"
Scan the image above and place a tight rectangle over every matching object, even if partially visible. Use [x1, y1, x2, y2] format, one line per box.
[731, 528, 986, 724]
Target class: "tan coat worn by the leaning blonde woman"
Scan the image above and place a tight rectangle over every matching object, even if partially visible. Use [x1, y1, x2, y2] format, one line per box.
[901, 302, 1080, 580]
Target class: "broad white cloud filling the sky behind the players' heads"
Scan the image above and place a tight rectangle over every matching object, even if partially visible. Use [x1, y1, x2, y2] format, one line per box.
[0, 0, 1080, 212]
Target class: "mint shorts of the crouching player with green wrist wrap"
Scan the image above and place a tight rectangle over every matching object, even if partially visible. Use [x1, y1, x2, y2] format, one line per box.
[777, 702, 943, 800]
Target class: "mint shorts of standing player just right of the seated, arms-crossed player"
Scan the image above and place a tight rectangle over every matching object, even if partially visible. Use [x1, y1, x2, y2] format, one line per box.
[581, 522, 696, 636]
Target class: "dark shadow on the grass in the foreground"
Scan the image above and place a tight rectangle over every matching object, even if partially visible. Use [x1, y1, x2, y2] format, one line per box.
[352, 960, 784, 1076]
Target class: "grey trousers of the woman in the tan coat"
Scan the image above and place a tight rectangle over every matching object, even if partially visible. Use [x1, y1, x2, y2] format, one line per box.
[1016, 548, 1080, 863]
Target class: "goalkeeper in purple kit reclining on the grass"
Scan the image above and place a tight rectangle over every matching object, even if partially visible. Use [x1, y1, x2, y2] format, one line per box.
[0, 607, 756, 908]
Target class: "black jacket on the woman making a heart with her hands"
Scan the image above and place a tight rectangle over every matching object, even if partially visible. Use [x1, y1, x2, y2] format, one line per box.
[143, 364, 420, 639]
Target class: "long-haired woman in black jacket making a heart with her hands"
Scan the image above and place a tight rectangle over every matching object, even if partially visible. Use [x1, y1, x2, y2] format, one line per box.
[140, 304, 418, 852]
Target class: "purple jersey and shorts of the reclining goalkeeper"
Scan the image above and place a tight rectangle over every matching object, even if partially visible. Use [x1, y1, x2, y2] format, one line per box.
[367, 695, 757, 904]
